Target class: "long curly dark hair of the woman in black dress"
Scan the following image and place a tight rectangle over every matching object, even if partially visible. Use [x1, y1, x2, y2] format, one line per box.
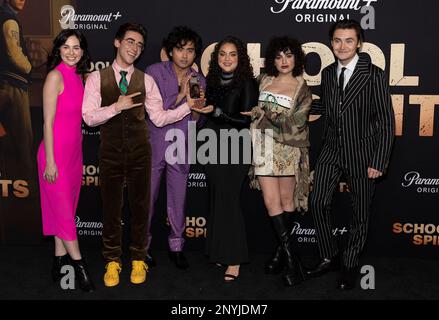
[206, 36, 254, 86]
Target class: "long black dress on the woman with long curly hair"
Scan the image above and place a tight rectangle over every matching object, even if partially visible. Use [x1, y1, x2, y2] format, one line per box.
[204, 79, 258, 265]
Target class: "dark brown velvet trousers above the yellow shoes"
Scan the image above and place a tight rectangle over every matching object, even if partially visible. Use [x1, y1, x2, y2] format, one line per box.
[99, 141, 151, 262]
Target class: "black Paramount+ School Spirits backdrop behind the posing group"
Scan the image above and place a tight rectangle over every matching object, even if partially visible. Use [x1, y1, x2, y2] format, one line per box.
[0, 0, 439, 258]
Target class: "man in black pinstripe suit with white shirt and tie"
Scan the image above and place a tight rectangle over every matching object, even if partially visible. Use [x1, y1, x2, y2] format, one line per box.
[308, 20, 395, 290]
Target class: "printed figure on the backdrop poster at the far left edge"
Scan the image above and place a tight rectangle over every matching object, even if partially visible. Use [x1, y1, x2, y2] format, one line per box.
[0, 0, 35, 180]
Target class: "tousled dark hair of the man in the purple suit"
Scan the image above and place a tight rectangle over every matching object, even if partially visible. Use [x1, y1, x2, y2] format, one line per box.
[162, 26, 203, 60]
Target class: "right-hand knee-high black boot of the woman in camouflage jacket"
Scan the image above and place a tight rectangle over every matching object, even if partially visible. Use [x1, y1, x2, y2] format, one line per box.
[271, 213, 305, 286]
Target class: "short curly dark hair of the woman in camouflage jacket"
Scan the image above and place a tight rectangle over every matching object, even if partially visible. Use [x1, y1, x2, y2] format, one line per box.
[265, 36, 305, 77]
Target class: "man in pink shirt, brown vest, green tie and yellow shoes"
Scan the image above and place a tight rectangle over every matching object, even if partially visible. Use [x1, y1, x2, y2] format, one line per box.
[82, 23, 194, 287]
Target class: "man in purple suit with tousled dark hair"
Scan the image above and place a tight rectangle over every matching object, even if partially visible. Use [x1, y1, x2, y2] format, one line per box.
[146, 26, 206, 270]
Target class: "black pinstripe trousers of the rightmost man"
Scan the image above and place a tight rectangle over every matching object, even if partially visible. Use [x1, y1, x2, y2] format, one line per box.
[310, 163, 375, 268]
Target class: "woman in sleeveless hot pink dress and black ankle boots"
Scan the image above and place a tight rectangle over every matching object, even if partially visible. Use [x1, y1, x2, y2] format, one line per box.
[38, 30, 94, 292]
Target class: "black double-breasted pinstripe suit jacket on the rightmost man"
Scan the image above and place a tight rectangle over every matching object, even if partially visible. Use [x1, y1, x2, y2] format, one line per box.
[311, 53, 395, 177]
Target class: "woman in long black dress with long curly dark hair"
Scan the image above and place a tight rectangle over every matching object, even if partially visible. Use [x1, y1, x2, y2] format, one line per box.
[204, 36, 258, 281]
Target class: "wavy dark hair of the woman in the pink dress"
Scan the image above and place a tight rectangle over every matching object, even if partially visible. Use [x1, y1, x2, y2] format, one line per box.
[47, 29, 90, 75]
